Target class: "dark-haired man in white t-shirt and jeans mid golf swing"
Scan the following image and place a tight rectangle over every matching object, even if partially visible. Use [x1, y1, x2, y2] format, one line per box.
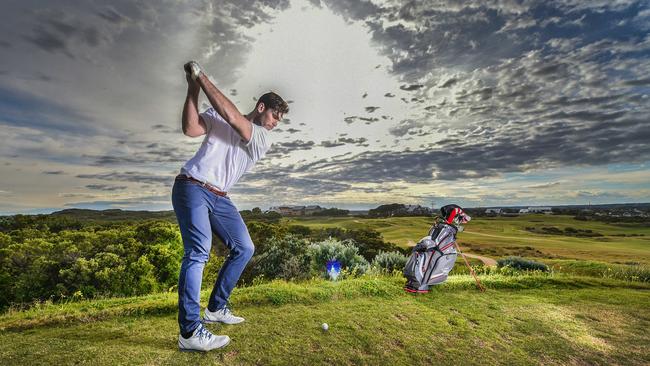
[172, 61, 289, 351]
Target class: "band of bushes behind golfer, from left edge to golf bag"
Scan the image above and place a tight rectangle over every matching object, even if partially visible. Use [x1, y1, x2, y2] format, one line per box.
[0, 216, 399, 310]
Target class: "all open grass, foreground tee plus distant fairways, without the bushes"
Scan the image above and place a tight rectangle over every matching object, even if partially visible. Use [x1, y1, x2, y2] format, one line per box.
[0, 215, 650, 366]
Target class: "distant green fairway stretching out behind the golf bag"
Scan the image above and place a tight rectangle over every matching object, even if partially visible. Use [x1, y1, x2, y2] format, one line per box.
[285, 214, 650, 264]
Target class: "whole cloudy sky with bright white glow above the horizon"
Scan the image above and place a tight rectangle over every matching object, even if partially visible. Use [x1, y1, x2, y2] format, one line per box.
[0, 0, 650, 214]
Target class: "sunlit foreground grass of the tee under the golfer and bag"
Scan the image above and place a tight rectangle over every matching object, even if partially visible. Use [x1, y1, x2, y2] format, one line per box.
[0, 274, 650, 365]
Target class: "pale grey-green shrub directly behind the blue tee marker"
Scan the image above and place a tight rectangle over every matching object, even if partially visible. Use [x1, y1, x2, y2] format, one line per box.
[308, 240, 370, 277]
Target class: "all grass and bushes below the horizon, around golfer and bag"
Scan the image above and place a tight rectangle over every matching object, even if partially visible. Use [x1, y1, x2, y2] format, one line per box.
[0, 210, 650, 365]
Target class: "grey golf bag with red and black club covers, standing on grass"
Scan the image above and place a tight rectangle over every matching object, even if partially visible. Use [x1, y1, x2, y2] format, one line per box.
[404, 205, 471, 292]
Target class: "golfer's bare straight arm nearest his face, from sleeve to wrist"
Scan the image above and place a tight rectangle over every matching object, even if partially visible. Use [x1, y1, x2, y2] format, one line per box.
[196, 73, 253, 142]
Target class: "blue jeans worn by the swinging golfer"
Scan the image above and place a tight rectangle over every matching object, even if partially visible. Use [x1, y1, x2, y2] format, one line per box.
[172, 179, 255, 333]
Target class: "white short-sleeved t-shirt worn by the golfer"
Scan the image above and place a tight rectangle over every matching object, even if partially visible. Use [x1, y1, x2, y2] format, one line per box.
[181, 108, 271, 192]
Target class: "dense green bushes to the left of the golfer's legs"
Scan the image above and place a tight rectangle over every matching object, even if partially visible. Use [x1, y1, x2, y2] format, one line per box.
[0, 217, 183, 309]
